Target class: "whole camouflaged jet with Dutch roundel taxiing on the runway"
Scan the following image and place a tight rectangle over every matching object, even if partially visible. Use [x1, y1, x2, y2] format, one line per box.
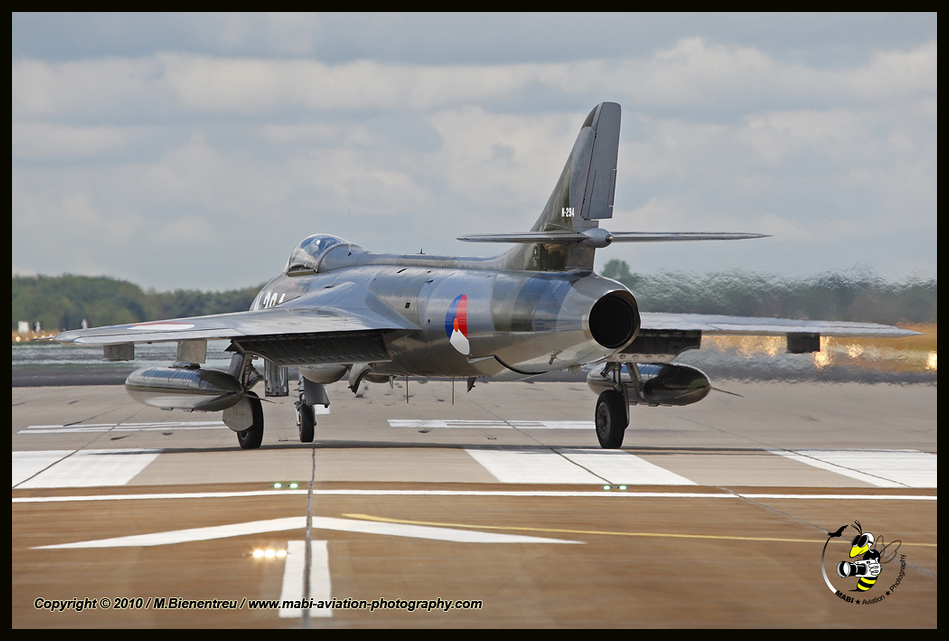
[55, 102, 914, 449]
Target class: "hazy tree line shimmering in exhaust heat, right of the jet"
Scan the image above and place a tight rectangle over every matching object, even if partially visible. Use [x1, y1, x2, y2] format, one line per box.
[602, 259, 936, 324]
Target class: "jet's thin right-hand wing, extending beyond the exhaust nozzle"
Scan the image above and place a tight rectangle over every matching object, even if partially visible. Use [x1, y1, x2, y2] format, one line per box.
[640, 312, 919, 338]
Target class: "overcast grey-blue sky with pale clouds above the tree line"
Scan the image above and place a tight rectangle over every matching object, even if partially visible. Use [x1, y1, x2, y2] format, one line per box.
[12, 13, 936, 290]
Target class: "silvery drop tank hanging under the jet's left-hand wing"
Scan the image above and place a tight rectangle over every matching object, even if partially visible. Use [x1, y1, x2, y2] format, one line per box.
[125, 367, 244, 412]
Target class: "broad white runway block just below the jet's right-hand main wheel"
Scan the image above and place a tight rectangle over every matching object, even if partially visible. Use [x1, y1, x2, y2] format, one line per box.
[465, 448, 695, 485]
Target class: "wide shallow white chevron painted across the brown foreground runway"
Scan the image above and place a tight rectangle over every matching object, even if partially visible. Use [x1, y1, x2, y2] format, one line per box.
[34, 516, 580, 550]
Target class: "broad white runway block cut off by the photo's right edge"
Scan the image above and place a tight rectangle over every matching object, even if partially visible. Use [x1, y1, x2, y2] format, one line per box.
[771, 450, 936, 488]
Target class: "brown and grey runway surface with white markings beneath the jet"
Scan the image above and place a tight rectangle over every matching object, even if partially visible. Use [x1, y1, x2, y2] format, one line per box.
[11, 380, 937, 629]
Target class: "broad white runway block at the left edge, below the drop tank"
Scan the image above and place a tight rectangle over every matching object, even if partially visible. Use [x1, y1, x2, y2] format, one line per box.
[13, 449, 162, 488]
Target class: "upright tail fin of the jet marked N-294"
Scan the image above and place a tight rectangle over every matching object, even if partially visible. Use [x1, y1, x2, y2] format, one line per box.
[504, 102, 620, 271]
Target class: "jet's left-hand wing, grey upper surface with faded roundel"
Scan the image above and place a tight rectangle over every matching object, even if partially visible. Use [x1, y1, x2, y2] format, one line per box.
[54, 283, 418, 345]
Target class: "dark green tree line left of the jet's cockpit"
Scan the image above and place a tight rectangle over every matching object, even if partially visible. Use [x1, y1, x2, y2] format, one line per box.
[11, 274, 263, 330]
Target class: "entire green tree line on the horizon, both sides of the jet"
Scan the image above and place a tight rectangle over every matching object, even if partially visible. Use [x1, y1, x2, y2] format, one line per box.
[11, 259, 936, 330]
